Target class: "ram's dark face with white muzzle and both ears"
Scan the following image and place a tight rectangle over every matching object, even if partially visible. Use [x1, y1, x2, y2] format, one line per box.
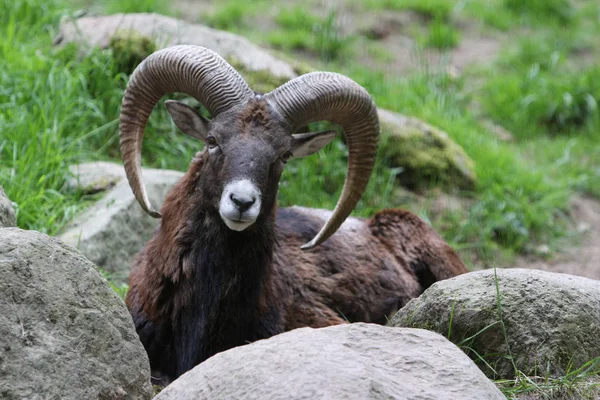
[167, 100, 335, 231]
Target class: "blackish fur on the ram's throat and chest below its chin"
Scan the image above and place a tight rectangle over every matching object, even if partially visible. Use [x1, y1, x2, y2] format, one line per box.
[172, 208, 282, 372]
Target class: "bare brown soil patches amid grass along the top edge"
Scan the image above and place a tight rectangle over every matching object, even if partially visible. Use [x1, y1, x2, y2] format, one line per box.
[170, 0, 501, 75]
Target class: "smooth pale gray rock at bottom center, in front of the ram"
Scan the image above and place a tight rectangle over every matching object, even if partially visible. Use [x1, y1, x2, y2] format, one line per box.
[156, 323, 504, 400]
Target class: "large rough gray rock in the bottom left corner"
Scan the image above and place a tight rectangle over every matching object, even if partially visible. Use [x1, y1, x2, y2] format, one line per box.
[0, 228, 153, 399]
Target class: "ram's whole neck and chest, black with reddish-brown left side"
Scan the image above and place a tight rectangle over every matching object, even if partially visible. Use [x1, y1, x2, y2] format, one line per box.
[127, 157, 283, 378]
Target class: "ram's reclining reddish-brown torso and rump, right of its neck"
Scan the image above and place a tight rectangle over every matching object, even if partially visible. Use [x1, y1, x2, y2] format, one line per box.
[274, 207, 468, 330]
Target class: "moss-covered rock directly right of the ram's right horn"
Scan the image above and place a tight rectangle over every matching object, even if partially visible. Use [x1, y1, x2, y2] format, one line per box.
[379, 109, 477, 190]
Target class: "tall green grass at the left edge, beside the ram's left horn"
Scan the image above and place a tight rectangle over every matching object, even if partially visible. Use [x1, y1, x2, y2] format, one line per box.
[0, 0, 189, 234]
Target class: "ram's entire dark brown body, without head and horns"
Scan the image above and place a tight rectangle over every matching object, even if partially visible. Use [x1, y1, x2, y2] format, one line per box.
[126, 154, 467, 384]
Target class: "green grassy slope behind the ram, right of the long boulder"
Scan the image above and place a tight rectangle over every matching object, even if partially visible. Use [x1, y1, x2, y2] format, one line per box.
[180, 0, 600, 261]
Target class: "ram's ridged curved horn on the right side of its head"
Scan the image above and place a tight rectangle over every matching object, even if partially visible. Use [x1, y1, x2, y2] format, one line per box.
[264, 72, 379, 250]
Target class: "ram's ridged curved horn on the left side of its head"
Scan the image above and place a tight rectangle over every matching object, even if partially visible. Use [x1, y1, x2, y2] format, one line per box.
[120, 45, 253, 218]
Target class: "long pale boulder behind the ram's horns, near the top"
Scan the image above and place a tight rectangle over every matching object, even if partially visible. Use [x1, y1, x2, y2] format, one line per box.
[56, 13, 306, 92]
